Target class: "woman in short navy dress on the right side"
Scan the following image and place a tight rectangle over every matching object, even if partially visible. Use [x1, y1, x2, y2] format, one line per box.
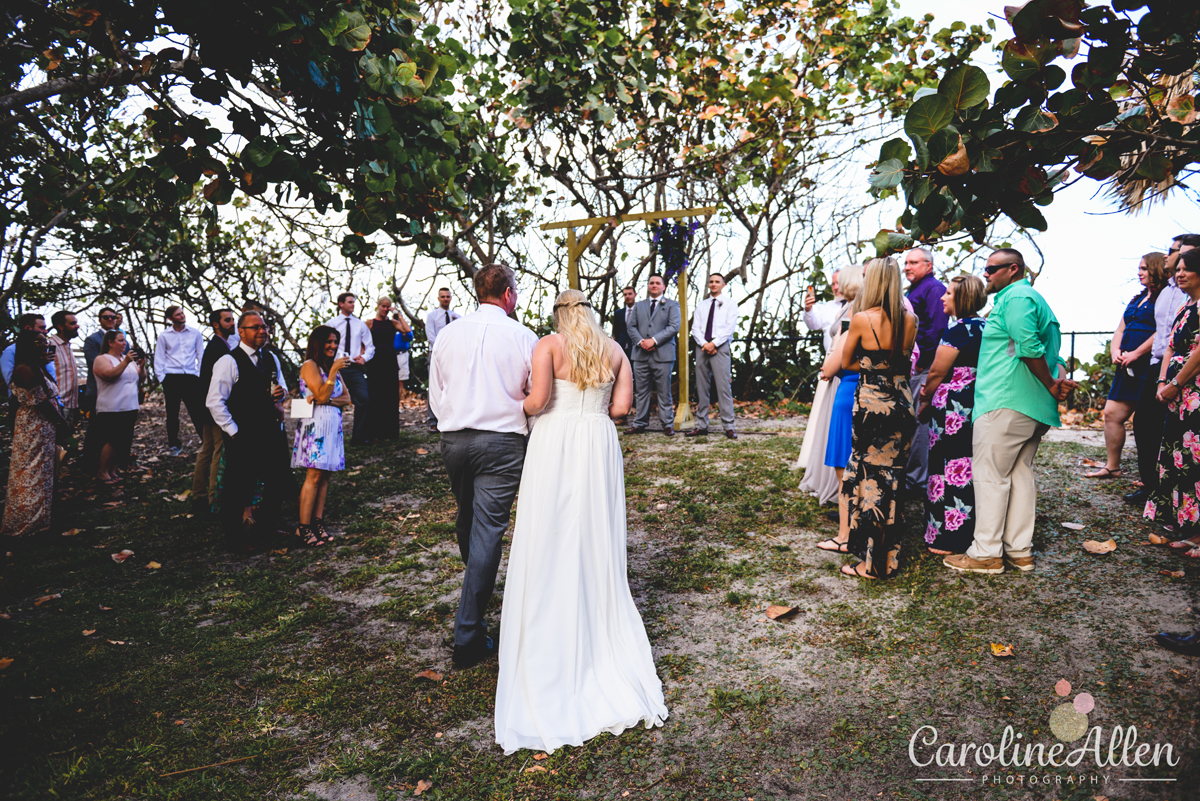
[1084, 253, 1166, 478]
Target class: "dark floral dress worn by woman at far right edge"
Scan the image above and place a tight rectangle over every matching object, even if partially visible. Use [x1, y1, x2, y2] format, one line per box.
[1142, 301, 1200, 538]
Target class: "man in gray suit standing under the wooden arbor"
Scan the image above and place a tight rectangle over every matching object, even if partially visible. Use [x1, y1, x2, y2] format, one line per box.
[625, 272, 679, 436]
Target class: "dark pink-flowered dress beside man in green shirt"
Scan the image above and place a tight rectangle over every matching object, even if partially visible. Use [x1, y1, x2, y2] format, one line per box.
[925, 317, 985, 554]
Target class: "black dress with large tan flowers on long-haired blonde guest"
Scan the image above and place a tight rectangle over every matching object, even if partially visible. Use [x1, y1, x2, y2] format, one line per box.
[841, 335, 917, 578]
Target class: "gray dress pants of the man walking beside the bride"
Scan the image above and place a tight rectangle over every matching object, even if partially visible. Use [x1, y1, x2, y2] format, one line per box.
[442, 429, 526, 650]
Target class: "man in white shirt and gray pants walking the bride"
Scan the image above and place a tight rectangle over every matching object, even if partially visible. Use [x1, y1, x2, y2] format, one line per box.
[430, 264, 538, 668]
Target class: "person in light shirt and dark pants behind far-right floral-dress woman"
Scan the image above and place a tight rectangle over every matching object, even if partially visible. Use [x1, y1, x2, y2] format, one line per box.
[1124, 244, 1200, 508]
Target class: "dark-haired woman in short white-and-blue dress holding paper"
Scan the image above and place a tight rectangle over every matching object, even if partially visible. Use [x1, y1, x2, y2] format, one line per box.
[292, 325, 350, 547]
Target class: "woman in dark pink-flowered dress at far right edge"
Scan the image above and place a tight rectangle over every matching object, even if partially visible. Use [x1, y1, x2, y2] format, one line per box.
[1144, 248, 1200, 559]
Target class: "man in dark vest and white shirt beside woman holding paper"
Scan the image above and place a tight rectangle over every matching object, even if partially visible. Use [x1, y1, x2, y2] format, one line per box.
[205, 312, 295, 553]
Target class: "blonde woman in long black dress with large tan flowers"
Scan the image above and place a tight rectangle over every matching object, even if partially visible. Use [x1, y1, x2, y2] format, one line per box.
[841, 259, 917, 578]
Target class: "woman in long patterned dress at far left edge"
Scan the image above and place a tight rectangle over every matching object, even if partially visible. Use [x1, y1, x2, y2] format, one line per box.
[0, 330, 66, 537]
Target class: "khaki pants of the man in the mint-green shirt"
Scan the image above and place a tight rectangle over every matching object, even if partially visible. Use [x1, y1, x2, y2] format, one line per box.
[967, 409, 1050, 559]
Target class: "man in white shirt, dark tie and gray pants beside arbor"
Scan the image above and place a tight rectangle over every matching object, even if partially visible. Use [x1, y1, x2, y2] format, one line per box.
[684, 272, 738, 439]
